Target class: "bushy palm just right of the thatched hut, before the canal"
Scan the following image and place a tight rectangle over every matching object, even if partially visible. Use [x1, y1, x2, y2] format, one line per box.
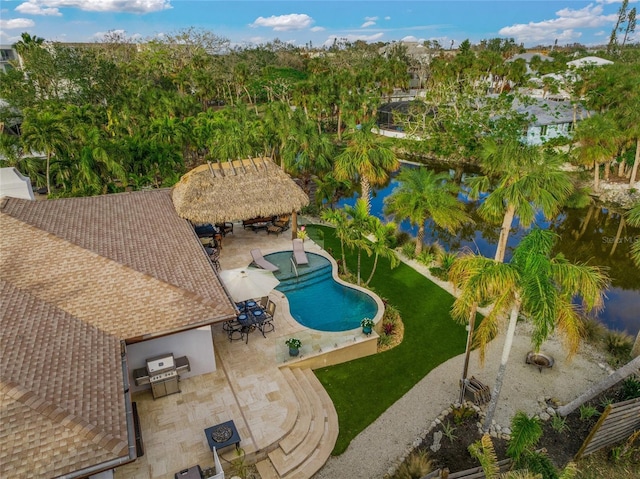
[334, 122, 400, 213]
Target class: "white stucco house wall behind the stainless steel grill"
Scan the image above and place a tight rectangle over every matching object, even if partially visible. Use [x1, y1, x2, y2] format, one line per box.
[127, 326, 216, 392]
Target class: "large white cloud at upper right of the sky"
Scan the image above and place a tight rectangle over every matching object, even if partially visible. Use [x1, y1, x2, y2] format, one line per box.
[498, 4, 617, 43]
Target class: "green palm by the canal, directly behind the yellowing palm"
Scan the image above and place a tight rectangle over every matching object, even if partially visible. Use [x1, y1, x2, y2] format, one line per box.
[467, 139, 573, 261]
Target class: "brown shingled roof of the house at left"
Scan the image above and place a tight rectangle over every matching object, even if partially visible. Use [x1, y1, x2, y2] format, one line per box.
[0, 190, 235, 478]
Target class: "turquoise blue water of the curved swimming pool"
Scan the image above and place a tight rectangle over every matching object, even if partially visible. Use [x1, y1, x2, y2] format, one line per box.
[265, 251, 378, 331]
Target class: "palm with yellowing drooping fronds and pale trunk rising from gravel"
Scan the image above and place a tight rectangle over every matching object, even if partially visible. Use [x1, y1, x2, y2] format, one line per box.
[450, 228, 608, 432]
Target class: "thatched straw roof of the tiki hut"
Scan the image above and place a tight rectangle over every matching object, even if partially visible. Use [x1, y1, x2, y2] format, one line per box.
[172, 158, 309, 223]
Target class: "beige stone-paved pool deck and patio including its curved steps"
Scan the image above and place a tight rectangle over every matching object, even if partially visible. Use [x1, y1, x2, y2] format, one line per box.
[115, 223, 376, 479]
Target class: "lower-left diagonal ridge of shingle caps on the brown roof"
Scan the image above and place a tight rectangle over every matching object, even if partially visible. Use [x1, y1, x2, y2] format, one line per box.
[0, 377, 129, 456]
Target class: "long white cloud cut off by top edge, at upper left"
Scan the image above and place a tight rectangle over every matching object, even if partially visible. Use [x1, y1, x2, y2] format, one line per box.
[16, 0, 172, 15]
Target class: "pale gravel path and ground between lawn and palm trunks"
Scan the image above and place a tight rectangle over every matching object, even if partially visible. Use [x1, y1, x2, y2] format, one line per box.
[313, 261, 610, 479]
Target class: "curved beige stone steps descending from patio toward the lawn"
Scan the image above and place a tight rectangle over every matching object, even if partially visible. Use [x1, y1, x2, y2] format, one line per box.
[256, 368, 338, 479]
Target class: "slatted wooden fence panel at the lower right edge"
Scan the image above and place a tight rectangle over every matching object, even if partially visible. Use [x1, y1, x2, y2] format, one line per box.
[575, 398, 640, 460]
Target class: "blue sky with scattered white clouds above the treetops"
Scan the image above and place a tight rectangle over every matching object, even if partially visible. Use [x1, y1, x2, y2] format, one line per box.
[0, 0, 640, 48]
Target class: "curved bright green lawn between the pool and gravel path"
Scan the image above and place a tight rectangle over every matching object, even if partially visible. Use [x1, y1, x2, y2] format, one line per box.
[310, 226, 466, 455]
